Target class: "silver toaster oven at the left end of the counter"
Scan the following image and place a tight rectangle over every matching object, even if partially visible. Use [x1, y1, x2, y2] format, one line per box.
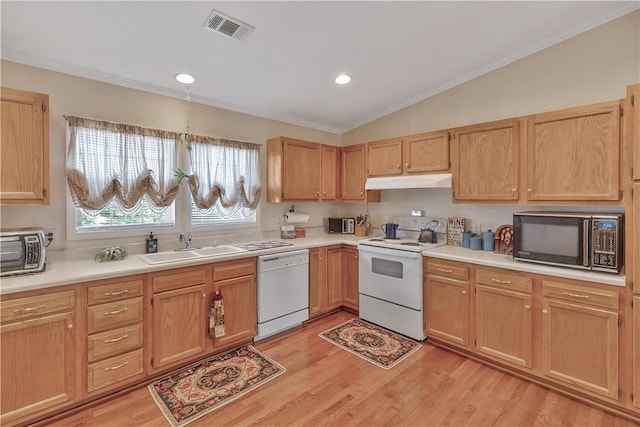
[0, 228, 47, 276]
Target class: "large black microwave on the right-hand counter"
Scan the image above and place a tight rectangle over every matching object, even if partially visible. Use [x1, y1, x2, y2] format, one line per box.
[513, 211, 624, 273]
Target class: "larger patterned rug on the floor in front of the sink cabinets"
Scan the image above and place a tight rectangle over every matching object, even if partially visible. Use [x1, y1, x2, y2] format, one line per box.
[148, 345, 286, 427]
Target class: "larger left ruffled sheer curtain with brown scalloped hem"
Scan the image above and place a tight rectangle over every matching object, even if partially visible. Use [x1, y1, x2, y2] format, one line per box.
[66, 117, 180, 213]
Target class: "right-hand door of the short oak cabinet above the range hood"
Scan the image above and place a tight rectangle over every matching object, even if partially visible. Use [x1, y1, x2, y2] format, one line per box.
[402, 131, 450, 175]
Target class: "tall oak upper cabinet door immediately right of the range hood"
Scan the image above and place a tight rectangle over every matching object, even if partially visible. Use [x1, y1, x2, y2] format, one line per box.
[451, 120, 520, 201]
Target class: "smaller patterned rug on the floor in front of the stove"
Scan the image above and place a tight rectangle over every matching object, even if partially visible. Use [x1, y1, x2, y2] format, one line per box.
[318, 319, 420, 369]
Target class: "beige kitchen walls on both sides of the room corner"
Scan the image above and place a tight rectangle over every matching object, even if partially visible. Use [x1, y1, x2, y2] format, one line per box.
[0, 12, 640, 251]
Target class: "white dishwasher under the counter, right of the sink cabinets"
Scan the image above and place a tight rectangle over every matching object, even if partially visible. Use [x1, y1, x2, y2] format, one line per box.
[254, 249, 309, 341]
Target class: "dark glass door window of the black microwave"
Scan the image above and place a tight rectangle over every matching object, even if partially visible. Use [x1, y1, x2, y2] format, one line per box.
[520, 222, 581, 258]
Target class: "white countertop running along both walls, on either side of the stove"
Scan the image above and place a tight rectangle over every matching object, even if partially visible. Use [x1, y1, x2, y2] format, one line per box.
[0, 234, 625, 295]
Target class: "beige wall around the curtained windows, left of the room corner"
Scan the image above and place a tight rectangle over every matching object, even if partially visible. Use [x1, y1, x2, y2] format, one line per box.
[0, 61, 340, 252]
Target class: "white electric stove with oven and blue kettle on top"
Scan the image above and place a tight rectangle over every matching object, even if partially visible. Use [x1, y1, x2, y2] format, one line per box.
[358, 217, 447, 341]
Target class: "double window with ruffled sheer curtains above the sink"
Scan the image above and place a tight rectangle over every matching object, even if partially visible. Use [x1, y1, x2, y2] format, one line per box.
[67, 117, 261, 238]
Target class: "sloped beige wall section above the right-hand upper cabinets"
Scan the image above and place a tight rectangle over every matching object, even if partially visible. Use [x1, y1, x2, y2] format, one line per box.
[342, 11, 640, 145]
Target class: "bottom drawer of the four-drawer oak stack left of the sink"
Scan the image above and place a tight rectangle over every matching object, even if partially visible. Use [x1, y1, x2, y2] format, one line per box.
[87, 349, 144, 392]
